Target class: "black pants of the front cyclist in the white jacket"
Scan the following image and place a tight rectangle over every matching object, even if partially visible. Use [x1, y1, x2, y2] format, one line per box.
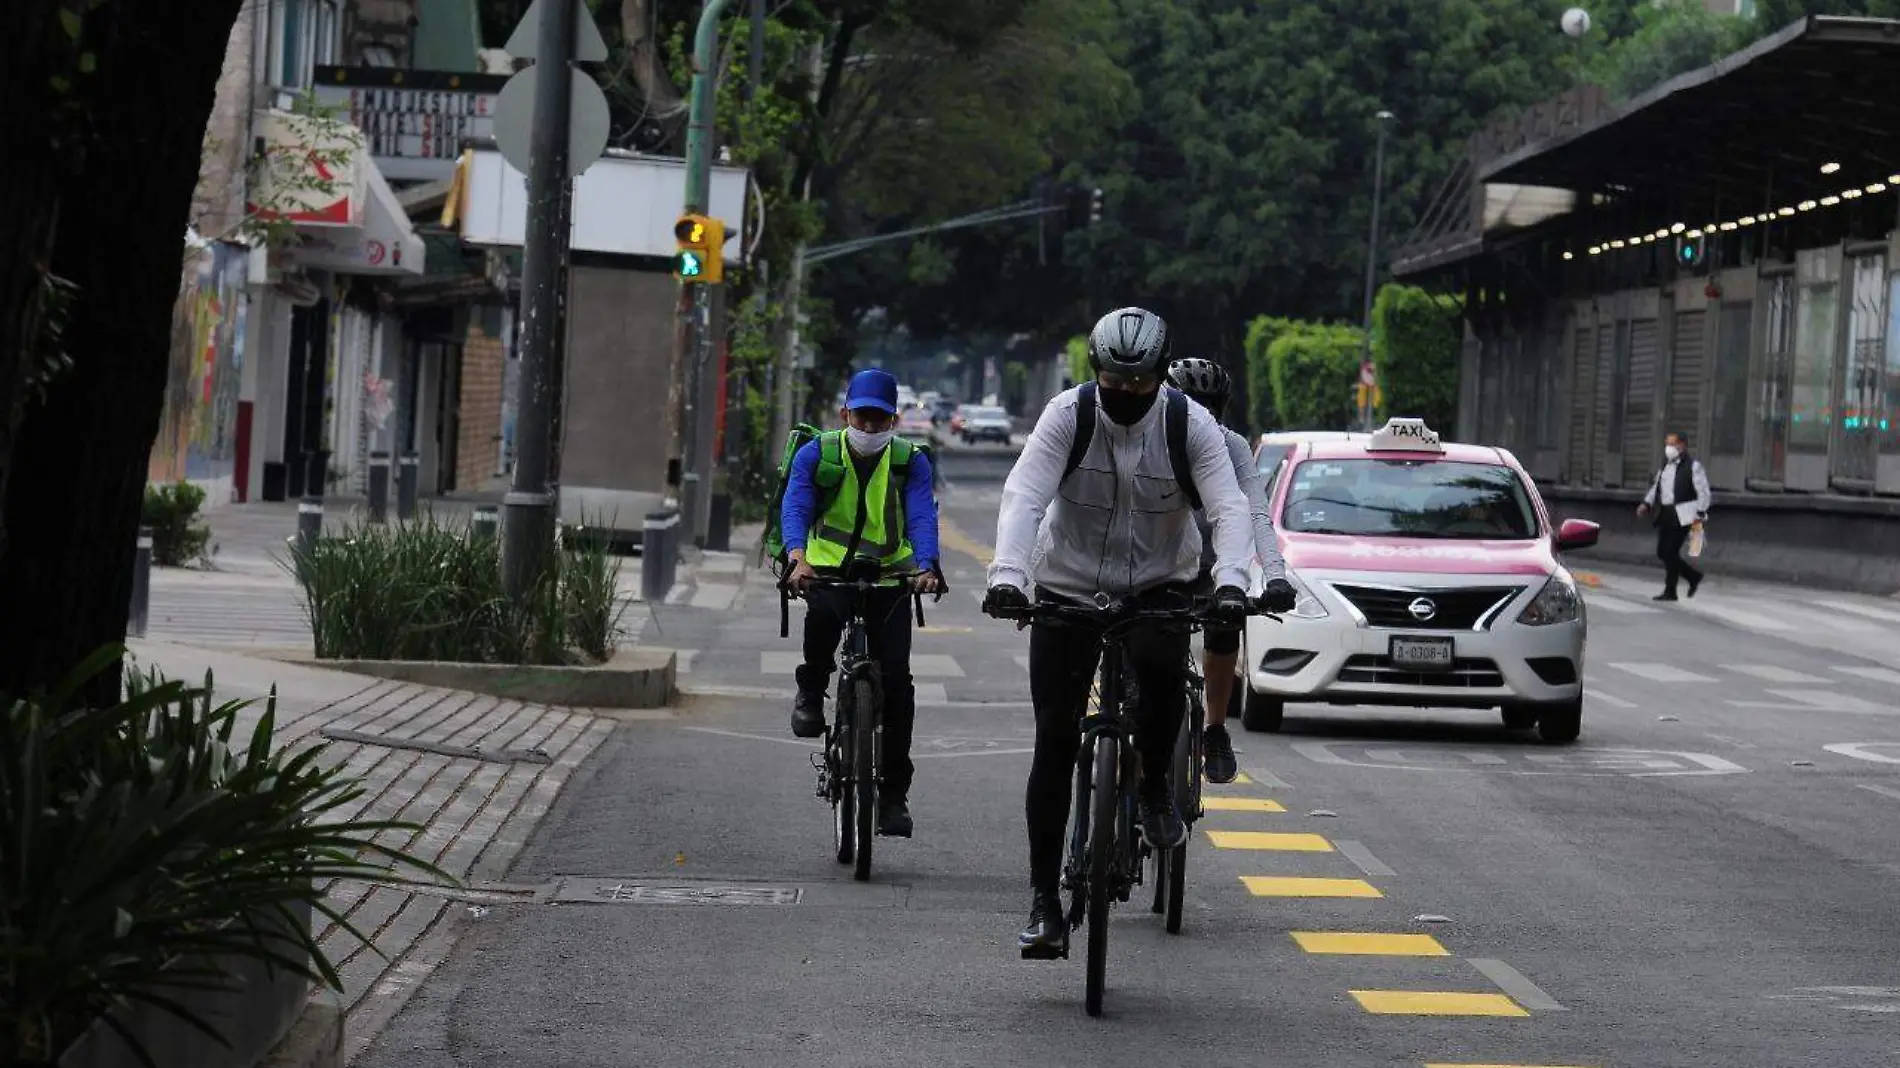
[1024, 581, 1188, 889]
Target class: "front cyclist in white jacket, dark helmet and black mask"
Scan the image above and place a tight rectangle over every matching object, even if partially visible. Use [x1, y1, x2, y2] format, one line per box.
[984, 308, 1254, 958]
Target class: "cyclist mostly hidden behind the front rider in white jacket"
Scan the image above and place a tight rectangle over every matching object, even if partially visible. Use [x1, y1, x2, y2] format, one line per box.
[1169, 357, 1296, 783]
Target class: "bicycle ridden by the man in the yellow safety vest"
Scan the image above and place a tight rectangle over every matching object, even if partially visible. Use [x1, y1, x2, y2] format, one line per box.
[779, 561, 948, 882]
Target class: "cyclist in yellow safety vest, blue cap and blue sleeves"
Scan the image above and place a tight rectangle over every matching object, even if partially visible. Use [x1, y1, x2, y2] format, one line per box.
[779, 369, 942, 838]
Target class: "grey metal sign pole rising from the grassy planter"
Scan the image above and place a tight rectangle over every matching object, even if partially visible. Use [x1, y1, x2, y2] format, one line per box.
[502, 2, 580, 606]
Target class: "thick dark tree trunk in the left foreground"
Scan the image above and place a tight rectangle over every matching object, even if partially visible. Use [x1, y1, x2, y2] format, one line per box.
[0, 0, 239, 701]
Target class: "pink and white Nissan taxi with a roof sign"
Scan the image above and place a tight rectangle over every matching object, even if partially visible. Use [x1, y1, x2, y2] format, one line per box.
[1241, 418, 1598, 743]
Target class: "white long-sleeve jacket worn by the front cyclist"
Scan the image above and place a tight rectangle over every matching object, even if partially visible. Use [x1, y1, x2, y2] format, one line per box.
[990, 381, 1254, 599]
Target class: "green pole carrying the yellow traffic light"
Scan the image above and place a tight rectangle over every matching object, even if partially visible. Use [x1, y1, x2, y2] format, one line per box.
[676, 0, 732, 544]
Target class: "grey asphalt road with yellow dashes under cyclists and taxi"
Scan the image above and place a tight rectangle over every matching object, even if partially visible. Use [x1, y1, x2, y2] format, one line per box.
[359, 438, 1900, 1068]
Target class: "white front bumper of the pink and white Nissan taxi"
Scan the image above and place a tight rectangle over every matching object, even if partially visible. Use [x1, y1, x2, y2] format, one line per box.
[1243, 572, 1587, 709]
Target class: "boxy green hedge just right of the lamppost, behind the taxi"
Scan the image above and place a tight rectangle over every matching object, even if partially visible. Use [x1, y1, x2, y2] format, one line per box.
[1372, 285, 1465, 433]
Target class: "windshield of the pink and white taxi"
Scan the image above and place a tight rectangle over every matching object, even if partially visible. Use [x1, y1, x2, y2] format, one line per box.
[1281, 458, 1537, 540]
